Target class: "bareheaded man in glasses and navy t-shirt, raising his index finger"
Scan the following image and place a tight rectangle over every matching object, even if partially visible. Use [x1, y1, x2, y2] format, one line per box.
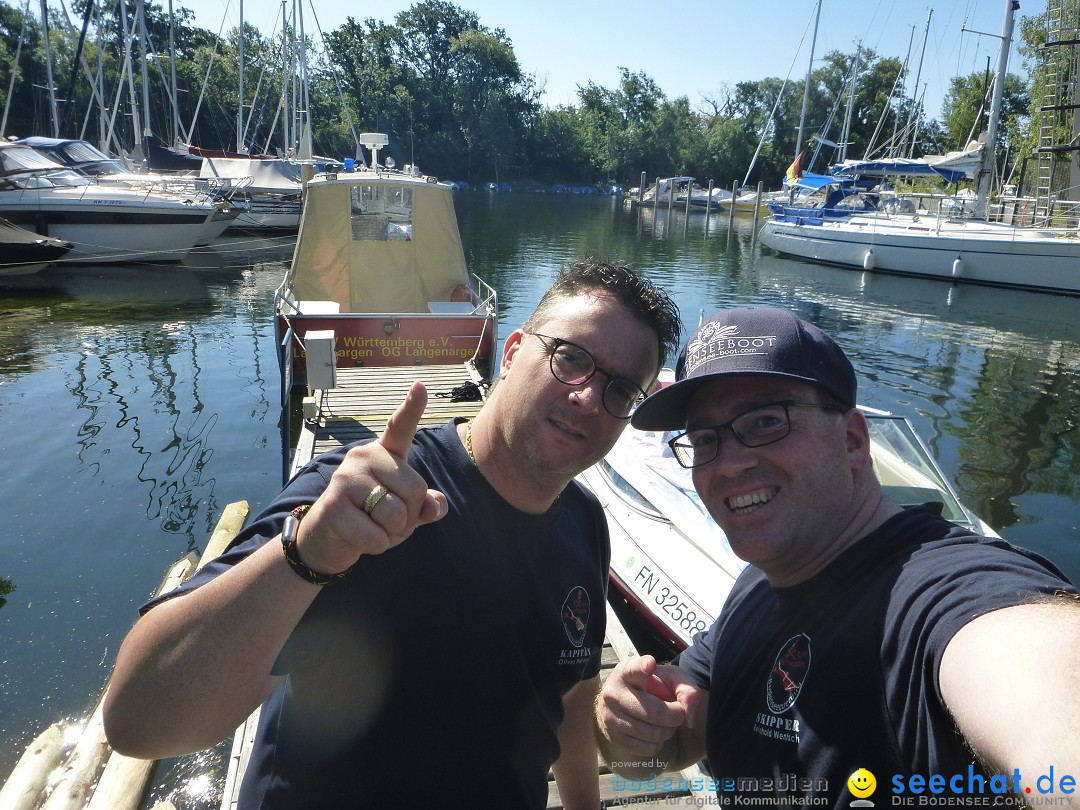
[105, 260, 679, 810]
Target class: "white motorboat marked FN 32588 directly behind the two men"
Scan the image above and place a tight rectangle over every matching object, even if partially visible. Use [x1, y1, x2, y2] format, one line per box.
[578, 397, 996, 654]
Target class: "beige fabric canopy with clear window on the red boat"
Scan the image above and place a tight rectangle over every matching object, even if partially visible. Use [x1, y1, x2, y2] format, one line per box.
[289, 179, 472, 313]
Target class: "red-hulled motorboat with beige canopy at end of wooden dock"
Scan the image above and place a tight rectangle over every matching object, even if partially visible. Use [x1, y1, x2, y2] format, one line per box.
[274, 133, 498, 388]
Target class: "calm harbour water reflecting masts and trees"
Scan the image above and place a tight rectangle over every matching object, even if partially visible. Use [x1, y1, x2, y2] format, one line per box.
[0, 192, 1080, 808]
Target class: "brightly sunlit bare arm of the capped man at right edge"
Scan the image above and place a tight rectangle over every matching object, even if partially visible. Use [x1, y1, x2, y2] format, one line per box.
[939, 596, 1080, 791]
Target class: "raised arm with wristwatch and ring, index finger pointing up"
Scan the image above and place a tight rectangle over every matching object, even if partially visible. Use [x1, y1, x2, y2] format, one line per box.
[104, 383, 446, 759]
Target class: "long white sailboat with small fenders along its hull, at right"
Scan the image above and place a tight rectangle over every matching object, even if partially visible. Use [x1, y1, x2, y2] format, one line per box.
[759, 0, 1080, 295]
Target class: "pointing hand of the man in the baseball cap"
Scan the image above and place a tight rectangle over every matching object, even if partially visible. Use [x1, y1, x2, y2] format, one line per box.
[596, 656, 708, 779]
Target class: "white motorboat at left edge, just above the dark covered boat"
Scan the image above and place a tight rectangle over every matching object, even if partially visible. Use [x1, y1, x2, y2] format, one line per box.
[0, 143, 228, 264]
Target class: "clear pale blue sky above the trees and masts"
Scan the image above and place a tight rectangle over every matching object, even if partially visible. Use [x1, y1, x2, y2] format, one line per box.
[177, 0, 1045, 123]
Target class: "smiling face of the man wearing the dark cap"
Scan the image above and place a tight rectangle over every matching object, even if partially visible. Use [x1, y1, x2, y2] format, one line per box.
[687, 375, 869, 586]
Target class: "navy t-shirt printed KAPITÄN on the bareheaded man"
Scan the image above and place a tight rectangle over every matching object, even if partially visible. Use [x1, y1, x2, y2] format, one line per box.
[147, 423, 610, 808]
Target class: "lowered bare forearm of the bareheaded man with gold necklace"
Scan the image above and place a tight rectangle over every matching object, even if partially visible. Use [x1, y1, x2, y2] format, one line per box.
[551, 675, 600, 810]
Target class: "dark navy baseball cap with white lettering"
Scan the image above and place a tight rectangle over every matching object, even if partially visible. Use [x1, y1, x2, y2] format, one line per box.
[631, 307, 858, 430]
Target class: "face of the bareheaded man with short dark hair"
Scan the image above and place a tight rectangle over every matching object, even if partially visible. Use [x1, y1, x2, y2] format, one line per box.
[491, 297, 659, 488]
